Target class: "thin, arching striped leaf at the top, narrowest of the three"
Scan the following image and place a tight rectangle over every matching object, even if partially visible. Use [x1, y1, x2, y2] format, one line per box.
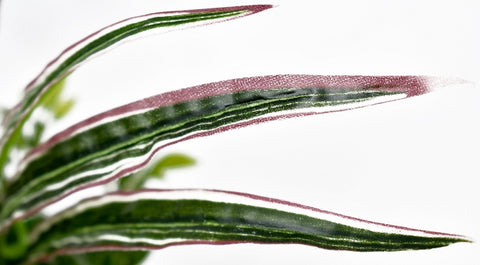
[0, 5, 271, 182]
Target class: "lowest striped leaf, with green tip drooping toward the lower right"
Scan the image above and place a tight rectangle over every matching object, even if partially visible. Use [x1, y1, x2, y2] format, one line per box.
[23, 190, 468, 262]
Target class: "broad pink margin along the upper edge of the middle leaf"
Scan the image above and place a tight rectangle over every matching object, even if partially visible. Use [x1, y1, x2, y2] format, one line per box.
[26, 75, 430, 159]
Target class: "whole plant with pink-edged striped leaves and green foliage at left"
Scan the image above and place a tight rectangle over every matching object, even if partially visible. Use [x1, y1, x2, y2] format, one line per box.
[0, 5, 469, 264]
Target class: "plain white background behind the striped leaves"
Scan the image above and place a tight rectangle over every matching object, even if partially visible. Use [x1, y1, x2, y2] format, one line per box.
[0, 0, 480, 264]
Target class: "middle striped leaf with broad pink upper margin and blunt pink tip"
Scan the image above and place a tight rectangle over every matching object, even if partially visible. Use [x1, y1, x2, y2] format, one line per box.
[1, 75, 434, 228]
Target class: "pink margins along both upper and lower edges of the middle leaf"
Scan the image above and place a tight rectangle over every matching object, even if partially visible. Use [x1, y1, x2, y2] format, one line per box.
[0, 75, 431, 232]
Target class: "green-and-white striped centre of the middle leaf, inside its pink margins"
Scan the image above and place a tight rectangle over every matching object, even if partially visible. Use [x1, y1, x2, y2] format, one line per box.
[2, 87, 400, 225]
